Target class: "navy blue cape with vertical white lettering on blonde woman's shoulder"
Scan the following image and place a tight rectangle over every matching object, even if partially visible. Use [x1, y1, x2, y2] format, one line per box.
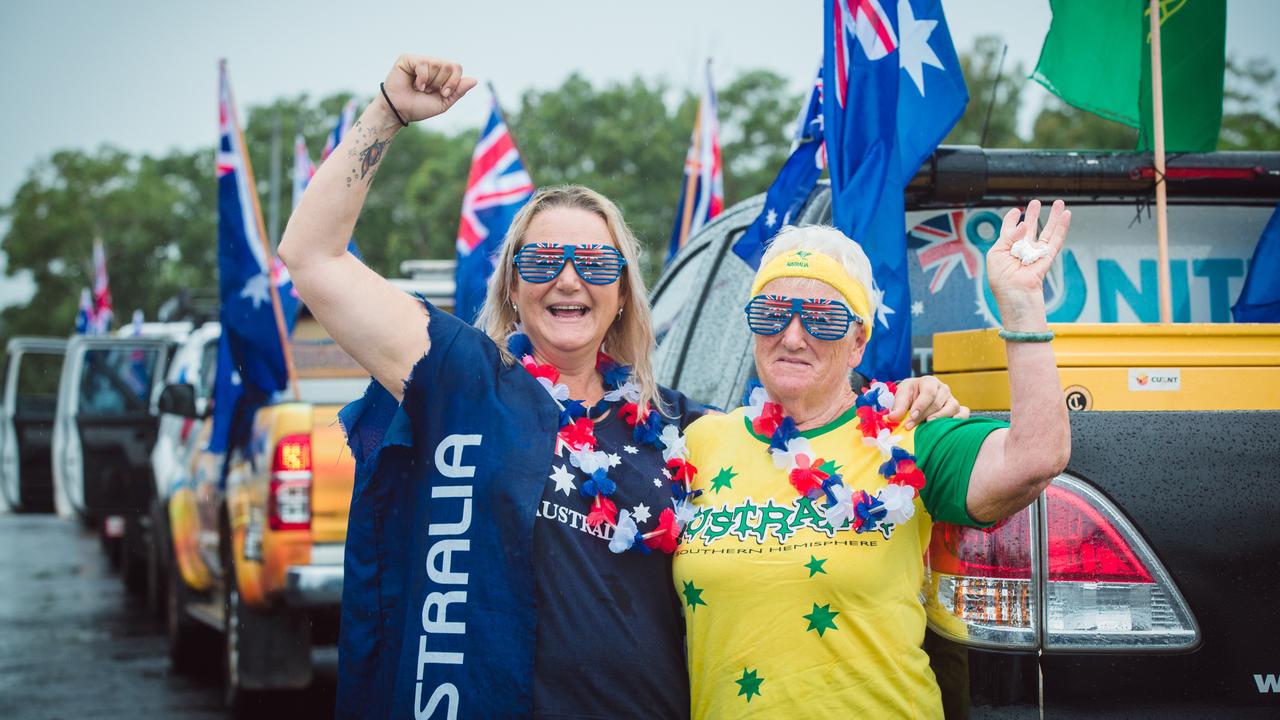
[337, 304, 559, 717]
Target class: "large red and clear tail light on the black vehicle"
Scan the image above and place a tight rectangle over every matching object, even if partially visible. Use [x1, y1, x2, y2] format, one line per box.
[925, 475, 1199, 651]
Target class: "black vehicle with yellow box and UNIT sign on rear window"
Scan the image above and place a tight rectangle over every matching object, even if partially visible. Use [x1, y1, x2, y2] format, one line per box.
[653, 147, 1280, 717]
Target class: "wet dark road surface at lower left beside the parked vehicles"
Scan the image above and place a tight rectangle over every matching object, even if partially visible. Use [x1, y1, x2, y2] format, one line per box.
[0, 514, 335, 720]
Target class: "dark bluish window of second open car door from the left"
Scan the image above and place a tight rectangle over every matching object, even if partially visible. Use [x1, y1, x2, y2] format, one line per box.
[79, 347, 164, 418]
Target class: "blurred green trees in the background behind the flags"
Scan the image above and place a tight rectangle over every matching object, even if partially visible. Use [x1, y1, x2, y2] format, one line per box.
[0, 36, 1280, 338]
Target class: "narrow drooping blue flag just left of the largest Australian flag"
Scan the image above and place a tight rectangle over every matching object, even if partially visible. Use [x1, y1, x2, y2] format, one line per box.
[733, 65, 827, 269]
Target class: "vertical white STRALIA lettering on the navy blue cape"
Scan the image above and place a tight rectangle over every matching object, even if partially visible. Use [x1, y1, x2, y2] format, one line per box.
[413, 434, 484, 720]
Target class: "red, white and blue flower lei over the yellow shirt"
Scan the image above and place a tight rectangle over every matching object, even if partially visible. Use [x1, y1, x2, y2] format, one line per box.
[745, 382, 924, 533]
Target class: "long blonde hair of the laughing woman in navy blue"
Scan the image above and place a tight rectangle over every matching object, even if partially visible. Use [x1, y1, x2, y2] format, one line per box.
[476, 184, 663, 411]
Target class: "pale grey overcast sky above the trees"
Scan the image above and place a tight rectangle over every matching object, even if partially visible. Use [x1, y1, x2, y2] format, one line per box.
[0, 0, 1280, 304]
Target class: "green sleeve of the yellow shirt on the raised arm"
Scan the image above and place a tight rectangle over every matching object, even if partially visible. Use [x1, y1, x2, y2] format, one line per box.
[915, 418, 1009, 528]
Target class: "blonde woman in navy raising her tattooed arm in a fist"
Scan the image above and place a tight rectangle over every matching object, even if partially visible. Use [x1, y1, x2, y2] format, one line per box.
[280, 55, 959, 717]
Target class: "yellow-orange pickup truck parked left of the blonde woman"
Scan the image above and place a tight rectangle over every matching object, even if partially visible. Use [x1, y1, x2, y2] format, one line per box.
[154, 310, 367, 711]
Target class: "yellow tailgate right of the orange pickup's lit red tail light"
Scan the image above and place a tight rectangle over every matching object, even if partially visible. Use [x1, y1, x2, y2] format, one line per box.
[311, 405, 356, 543]
